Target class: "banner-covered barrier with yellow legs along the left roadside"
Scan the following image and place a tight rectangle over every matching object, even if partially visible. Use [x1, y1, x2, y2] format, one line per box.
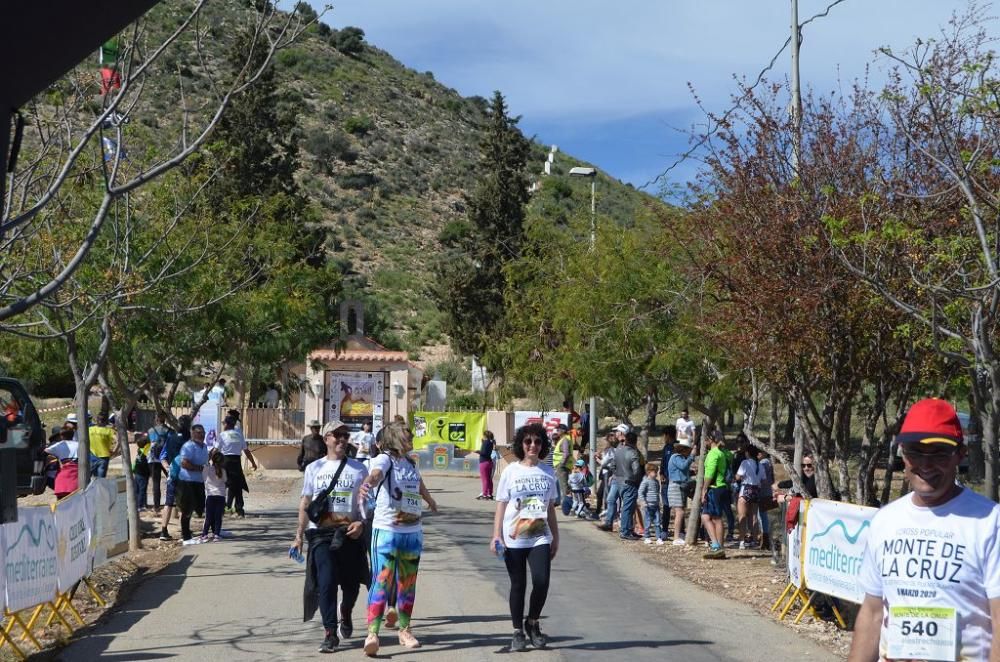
[0, 478, 128, 659]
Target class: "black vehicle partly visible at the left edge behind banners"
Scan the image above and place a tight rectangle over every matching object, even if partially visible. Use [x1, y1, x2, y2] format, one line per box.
[0, 377, 46, 496]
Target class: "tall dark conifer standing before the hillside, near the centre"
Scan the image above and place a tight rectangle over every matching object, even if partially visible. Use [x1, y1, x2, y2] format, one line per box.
[436, 92, 530, 372]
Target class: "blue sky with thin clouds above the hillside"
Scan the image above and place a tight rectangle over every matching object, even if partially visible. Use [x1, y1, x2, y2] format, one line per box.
[311, 0, 967, 195]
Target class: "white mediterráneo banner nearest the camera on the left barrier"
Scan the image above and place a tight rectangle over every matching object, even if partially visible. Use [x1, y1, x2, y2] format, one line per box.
[3, 506, 59, 611]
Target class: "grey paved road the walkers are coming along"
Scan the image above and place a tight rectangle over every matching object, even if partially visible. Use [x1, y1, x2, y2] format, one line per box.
[57, 477, 835, 662]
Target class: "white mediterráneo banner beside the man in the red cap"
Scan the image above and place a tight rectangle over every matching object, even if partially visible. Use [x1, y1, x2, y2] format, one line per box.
[789, 499, 878, 604]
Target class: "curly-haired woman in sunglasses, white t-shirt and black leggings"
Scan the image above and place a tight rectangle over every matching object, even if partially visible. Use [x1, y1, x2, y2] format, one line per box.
[490, 423, 559, 652]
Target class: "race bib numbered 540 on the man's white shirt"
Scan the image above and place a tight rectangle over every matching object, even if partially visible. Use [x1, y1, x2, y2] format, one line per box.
[886, 607, 958, 662]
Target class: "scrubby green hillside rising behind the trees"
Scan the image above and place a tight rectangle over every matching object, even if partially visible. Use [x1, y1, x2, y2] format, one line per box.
[121, 0, 668, 358]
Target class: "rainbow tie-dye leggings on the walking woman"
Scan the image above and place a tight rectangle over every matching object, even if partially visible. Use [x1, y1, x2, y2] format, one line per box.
[368, 529, 424, 633]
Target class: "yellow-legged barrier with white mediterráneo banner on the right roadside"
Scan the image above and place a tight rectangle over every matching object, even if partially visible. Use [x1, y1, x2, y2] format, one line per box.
[771, 499, 878, 628]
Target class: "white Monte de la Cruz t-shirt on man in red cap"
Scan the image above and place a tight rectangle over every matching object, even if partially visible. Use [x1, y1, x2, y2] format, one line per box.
[858, 489, 1000, 662]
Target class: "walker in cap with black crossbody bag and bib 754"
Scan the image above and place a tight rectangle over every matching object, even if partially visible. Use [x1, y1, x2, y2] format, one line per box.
[292, 420, 368, 653]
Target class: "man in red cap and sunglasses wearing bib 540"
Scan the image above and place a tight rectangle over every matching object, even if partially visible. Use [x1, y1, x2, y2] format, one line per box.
[848, 398, 1000, 662]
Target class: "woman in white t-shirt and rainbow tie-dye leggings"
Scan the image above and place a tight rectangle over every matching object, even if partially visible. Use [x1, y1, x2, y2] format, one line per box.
[360, 421, 437, 657]
